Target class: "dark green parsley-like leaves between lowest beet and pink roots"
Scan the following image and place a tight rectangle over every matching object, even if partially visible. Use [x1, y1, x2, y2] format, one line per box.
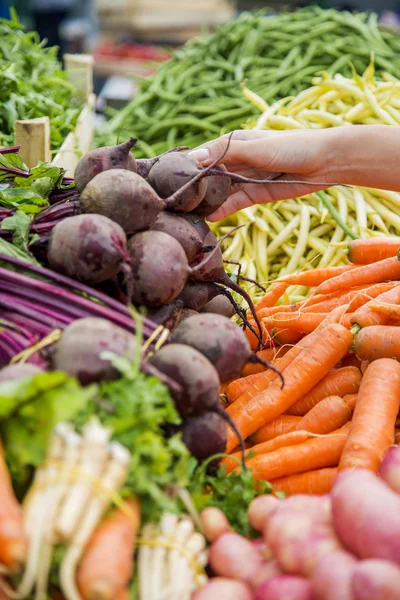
[188, 455, 273, 537]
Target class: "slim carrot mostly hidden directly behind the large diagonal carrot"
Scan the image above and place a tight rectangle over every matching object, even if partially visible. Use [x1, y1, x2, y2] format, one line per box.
[227, 306, 346, 406]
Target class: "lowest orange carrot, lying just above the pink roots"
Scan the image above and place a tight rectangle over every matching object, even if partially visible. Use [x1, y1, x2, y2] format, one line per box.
[271, 467, 337, 496]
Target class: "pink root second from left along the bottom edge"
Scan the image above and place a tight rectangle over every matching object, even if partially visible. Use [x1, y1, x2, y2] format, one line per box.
[254, 575, 314, 600]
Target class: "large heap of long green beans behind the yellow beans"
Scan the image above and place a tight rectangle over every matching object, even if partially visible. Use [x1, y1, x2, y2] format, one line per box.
[98, 6, 400, 157]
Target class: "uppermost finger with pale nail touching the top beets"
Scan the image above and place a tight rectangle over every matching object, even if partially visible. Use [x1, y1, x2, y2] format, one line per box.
[188, 137, 266, 168]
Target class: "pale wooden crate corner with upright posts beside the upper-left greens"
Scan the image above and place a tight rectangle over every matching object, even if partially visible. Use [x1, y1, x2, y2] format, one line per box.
[14, 54, 96, 176]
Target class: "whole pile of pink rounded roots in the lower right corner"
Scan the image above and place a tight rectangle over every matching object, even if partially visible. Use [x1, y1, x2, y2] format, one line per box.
[194, 446, 400, 600]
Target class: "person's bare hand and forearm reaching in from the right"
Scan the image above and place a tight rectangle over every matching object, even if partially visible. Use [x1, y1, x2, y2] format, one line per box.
[190, 125, 400, 221]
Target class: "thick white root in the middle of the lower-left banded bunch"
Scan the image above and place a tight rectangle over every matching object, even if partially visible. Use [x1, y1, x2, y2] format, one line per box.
[56, 419, 111, 540]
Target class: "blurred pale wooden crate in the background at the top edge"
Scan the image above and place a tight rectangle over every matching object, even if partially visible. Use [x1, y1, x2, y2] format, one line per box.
[96, 0, 235, 39]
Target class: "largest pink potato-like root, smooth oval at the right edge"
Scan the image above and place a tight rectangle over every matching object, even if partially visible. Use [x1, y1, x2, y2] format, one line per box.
[331, 469, 400, 564]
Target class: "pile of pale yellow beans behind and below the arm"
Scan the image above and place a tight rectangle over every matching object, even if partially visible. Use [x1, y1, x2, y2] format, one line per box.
[212, 62, 400, 302]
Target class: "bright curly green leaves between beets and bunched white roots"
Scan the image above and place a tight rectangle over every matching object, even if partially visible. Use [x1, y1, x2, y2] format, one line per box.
[75, 359, 190, 521]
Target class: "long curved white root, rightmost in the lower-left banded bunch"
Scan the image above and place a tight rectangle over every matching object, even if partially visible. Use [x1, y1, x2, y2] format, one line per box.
[60, 442, 130, 600]
